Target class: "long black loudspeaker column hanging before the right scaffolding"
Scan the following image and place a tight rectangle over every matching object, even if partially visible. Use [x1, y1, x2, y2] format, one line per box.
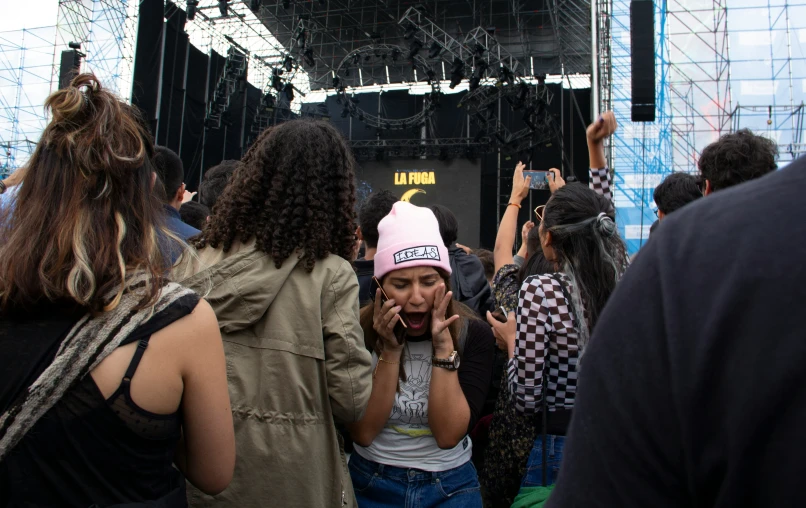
[630, 0, 655, 122]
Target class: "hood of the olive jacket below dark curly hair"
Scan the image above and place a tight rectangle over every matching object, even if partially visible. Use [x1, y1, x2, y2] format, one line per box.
[173, 239, 300, 333]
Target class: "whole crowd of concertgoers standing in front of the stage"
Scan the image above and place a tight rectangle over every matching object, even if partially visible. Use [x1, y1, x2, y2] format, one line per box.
[0, 74, 806, 508]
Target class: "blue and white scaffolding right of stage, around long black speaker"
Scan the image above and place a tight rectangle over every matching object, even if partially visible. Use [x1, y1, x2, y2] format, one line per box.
[596, 0, 806, 252]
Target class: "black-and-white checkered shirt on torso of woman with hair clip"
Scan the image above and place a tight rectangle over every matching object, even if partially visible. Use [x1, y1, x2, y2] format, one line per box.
[507, 273, 579, 414]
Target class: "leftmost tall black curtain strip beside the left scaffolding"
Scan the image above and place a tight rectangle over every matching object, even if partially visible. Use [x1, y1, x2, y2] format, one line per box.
[132, 0, 164, 133]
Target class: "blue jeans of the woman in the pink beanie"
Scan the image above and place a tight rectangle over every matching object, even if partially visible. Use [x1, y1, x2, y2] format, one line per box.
[349, 453, 482, 508]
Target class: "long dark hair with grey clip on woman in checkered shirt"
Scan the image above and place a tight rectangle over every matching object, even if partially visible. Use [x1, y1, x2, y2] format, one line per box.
[541, 185, 628, 338]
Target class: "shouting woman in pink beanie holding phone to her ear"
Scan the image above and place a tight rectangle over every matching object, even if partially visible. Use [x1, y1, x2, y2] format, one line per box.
[349, 202, 495, 508]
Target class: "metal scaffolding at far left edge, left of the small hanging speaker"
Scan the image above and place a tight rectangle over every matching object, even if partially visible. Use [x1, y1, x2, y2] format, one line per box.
[0, 26, 56, 178]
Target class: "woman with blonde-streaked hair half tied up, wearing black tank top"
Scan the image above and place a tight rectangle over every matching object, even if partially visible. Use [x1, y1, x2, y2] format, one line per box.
[0, 74, 235, 507]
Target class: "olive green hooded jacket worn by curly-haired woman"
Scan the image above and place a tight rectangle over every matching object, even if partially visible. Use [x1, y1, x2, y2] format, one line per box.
[173, 241, 372, 508]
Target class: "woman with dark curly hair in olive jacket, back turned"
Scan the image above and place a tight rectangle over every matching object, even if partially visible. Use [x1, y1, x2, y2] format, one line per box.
[174, 120, 372, 507]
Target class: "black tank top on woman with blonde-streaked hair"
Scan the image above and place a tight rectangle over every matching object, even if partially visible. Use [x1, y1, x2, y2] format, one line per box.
[0, 295, 199, 508]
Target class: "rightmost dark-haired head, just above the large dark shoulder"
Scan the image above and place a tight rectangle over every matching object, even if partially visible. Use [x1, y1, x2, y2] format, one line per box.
[698, 129, 778, 191]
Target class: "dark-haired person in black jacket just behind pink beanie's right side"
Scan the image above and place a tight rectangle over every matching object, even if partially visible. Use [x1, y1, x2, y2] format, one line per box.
[431, 205, 493, 317]
